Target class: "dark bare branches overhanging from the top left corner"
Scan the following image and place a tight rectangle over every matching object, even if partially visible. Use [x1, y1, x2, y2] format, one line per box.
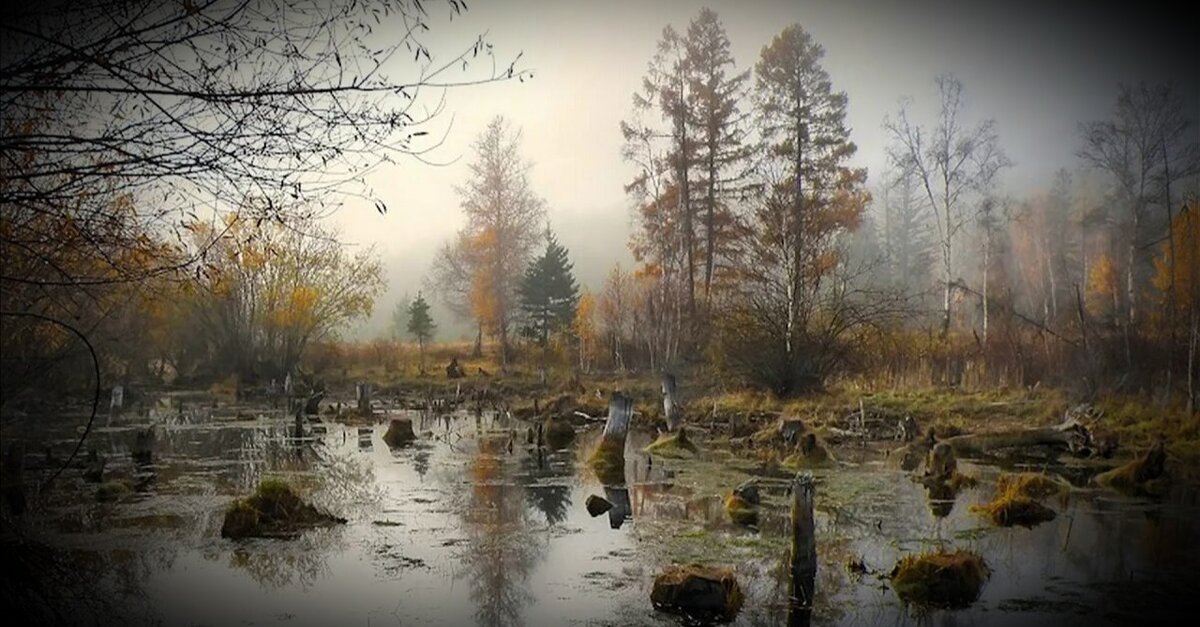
[0, 0, 528, 302]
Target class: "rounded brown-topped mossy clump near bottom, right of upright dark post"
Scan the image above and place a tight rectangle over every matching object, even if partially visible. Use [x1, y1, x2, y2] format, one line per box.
[890, 550, 990, 608]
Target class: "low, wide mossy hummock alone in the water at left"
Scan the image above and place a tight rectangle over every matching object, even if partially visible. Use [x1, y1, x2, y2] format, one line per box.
[221, 479, 346, 539]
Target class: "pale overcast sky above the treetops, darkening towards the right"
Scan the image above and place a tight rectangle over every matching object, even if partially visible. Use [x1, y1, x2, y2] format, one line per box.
[336, 0, 1200, 335]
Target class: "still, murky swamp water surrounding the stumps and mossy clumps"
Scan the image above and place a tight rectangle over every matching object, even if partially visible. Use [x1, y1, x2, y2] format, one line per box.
[5, 398, 1200, 626]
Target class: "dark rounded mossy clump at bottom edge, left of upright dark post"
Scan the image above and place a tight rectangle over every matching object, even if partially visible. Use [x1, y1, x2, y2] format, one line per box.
[650, 563, 745, 623]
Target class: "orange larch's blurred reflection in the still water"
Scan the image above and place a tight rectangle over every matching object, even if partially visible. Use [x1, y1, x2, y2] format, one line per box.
[457, 438, 547, 626]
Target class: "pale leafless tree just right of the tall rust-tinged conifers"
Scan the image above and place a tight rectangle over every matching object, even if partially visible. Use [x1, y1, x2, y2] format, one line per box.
[883, 74, 1012, 334]
